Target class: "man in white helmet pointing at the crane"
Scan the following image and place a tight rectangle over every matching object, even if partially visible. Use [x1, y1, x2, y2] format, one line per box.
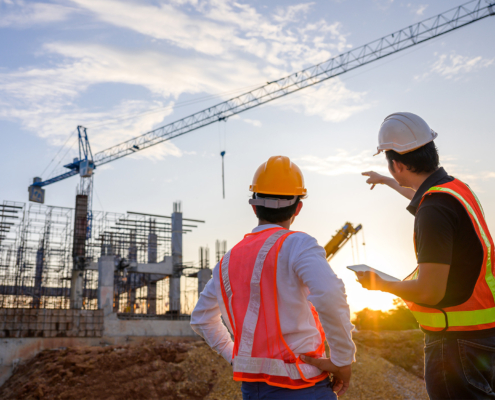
[358, 112, 495, 400]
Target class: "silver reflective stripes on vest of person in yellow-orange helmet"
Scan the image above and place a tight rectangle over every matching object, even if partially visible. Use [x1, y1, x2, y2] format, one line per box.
[219, 229, 324, 387]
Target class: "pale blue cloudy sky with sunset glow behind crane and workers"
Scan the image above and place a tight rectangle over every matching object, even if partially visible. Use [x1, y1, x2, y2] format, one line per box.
[0, 0, 495, 311]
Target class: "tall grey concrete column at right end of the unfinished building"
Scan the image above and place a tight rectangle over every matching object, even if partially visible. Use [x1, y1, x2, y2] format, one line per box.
[169, 203, 182, 314]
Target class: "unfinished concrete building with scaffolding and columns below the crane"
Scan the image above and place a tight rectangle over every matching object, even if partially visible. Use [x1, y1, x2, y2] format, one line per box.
[0, 195, 217, 337]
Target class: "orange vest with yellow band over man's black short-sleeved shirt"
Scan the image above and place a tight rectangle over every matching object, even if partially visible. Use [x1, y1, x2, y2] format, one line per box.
[406, 179, 495, 332]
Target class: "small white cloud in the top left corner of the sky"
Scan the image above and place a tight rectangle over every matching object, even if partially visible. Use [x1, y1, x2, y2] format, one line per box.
[0, 0, 76, 28]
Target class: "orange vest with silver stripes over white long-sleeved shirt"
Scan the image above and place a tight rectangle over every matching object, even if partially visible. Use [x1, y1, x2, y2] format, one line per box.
[214, 228, 328, 389]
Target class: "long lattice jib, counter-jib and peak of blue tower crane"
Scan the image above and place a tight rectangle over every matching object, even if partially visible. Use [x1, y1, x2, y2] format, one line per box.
[29, 0, 495, 203]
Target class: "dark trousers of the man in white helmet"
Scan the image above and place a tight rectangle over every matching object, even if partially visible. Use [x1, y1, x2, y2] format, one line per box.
[425, 333, 495, 400]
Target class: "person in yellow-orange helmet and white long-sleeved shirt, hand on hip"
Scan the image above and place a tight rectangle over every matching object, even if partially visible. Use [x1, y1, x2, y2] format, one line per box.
[191, 156, 355, 400]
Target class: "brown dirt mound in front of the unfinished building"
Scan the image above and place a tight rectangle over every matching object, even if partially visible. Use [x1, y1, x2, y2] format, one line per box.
[0, 340, 240, 400]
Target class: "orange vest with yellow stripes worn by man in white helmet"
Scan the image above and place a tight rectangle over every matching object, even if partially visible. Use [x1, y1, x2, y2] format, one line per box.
[406, 179, 495, 330]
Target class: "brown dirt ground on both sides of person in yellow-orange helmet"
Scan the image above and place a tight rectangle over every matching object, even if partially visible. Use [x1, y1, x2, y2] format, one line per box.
[0, 331, 428, 400]
